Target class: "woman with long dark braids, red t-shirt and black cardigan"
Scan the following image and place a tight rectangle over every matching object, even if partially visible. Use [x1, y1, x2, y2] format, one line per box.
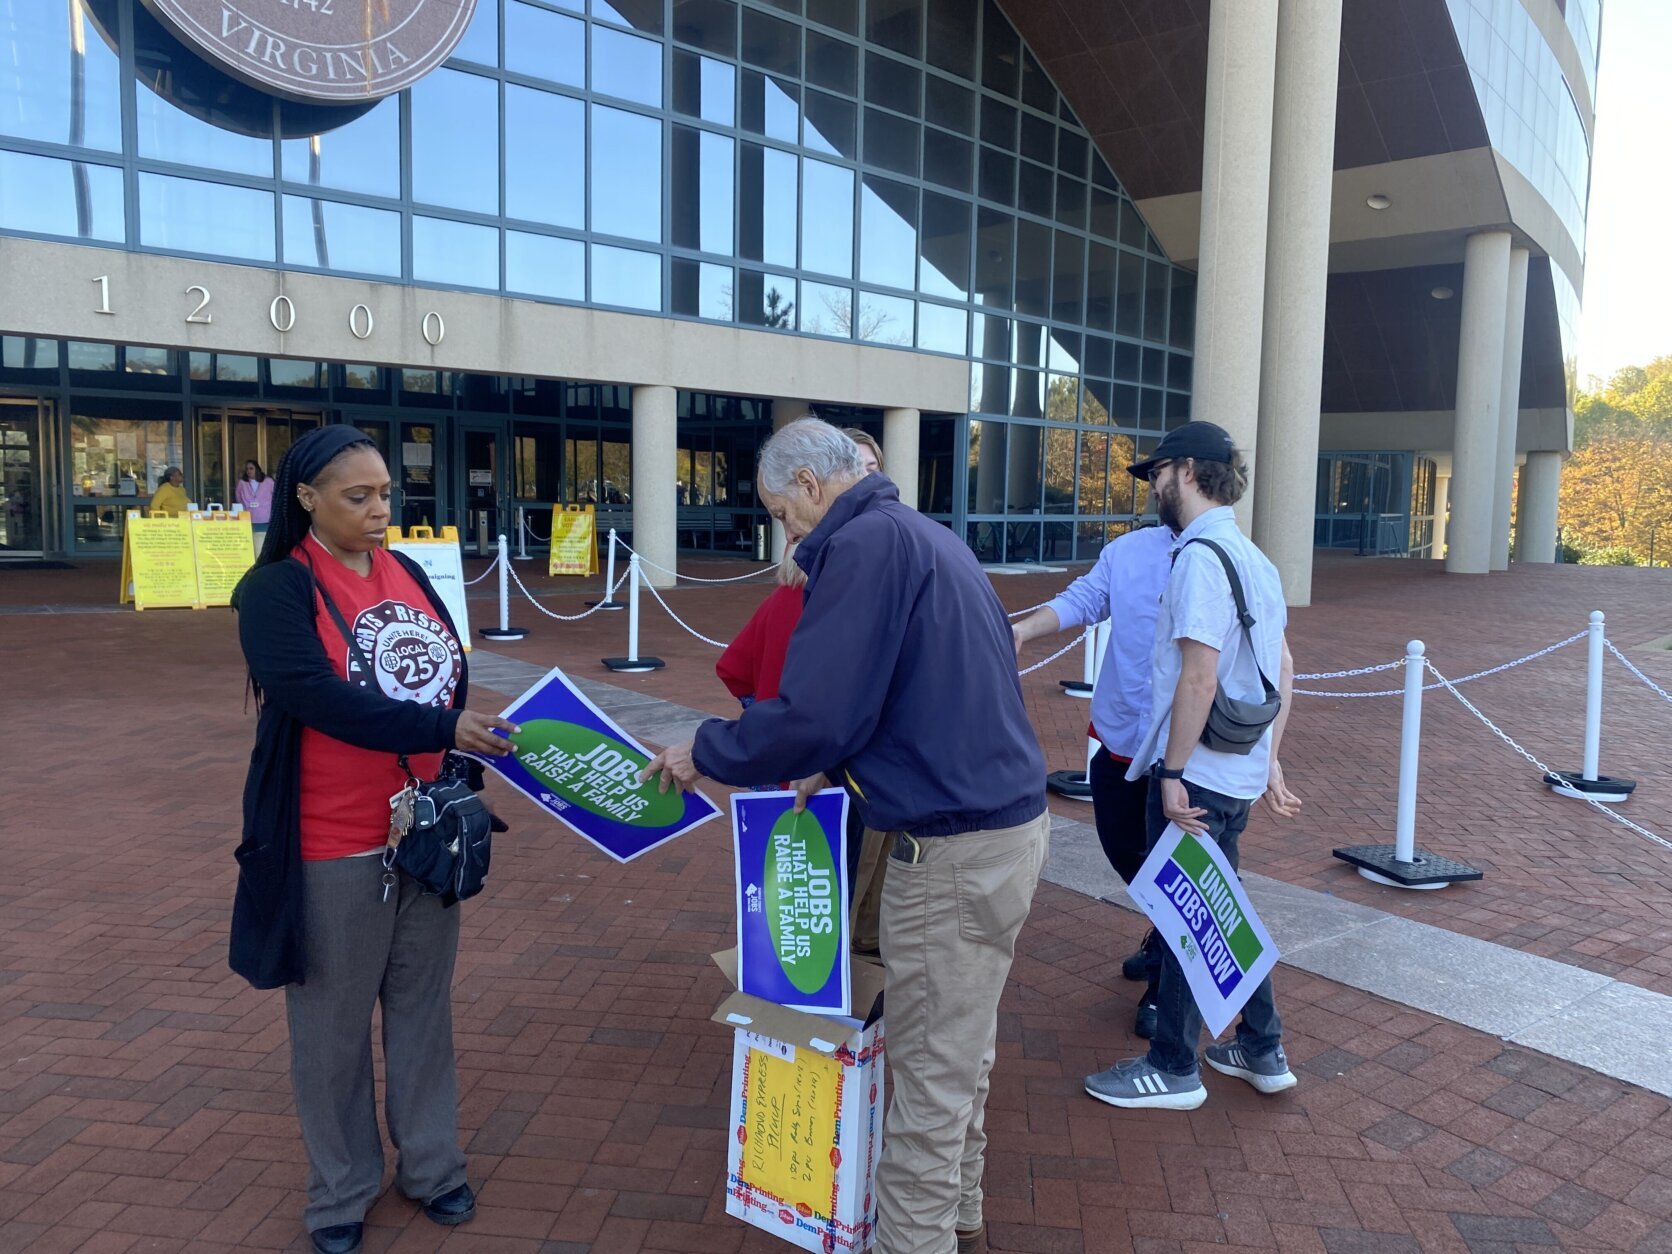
[231, 426, 517, 1254]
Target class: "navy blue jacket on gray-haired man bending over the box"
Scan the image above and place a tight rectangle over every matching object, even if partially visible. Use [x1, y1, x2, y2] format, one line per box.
[692, 475, 1045, 836]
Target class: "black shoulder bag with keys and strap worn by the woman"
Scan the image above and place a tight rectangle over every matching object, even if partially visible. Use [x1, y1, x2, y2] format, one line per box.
[309, 568, 493, 906]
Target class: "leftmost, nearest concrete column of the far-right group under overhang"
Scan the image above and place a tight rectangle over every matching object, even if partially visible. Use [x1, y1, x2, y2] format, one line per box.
[1446, 231, 1510, 575]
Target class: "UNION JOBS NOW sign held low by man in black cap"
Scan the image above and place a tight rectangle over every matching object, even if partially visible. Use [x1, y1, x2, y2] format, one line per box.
[1127, 823, 1277, 1037]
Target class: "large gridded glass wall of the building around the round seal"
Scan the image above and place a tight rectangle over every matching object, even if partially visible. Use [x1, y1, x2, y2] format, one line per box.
[0, 0, 1194, 560]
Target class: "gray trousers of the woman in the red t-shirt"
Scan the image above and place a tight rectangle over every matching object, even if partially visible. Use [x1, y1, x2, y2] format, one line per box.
[284, 854, 465, 1231]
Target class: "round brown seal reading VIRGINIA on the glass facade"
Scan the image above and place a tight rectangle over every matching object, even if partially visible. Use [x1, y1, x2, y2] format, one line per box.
[144, 0, 477, 104]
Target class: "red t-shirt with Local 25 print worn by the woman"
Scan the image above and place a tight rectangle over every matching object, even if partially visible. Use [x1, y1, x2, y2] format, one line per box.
[301, 535, 465, 863]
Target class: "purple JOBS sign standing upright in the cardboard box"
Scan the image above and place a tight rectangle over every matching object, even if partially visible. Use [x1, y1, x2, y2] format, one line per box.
[731, 788, 851, 1015]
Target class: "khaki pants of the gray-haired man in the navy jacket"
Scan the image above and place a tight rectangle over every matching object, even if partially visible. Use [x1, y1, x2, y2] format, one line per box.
[876, 813, 1050, 1254]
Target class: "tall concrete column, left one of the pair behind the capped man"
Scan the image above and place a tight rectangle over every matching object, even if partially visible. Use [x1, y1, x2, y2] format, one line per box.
[1190, 0, 1277, 528]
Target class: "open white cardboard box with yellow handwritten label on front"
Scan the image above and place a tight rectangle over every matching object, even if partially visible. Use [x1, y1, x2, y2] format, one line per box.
[714, 950, 884, 1254]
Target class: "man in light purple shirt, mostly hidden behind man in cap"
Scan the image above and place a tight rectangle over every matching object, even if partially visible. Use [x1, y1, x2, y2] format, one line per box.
[1010, 527, 1174, 1038]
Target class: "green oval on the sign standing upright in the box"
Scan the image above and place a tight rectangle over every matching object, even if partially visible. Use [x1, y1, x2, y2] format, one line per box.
[761, 809, 843, 993]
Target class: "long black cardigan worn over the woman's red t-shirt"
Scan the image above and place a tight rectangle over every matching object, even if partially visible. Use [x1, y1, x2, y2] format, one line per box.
[229, 553, 470, 988]
